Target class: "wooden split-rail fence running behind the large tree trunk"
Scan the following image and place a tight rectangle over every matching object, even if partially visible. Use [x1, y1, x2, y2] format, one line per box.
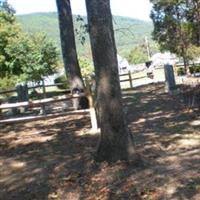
[0, 71, 147, 130]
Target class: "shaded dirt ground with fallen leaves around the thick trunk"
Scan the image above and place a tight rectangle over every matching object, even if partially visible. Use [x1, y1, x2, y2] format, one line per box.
[0, 84, 200, 200]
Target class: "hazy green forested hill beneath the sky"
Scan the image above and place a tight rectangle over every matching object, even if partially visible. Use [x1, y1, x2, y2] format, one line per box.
[17, 12, 153, 55]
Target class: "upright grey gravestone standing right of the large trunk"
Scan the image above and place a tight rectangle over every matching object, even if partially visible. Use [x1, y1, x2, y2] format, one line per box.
[164, 64, 177, 94]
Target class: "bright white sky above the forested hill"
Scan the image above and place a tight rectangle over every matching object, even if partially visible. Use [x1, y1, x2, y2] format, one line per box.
[8, 0, 151, 21]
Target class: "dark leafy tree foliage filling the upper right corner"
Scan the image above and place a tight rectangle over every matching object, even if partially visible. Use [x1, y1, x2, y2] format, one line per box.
[151, 0, 200, 63]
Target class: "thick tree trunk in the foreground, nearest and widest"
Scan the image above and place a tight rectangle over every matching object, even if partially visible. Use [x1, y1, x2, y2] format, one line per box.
[86, 0, 134, 161]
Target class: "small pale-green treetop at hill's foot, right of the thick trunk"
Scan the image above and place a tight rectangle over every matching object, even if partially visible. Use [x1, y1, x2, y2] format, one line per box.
[126, 46, 148, 64]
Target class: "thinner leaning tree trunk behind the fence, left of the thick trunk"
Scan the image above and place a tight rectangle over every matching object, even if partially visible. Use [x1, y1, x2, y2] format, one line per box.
[56, 0, 84, 90]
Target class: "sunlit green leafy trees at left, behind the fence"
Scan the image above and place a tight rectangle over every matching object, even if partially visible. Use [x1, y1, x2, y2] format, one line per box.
[0, 8, 58, 81]
